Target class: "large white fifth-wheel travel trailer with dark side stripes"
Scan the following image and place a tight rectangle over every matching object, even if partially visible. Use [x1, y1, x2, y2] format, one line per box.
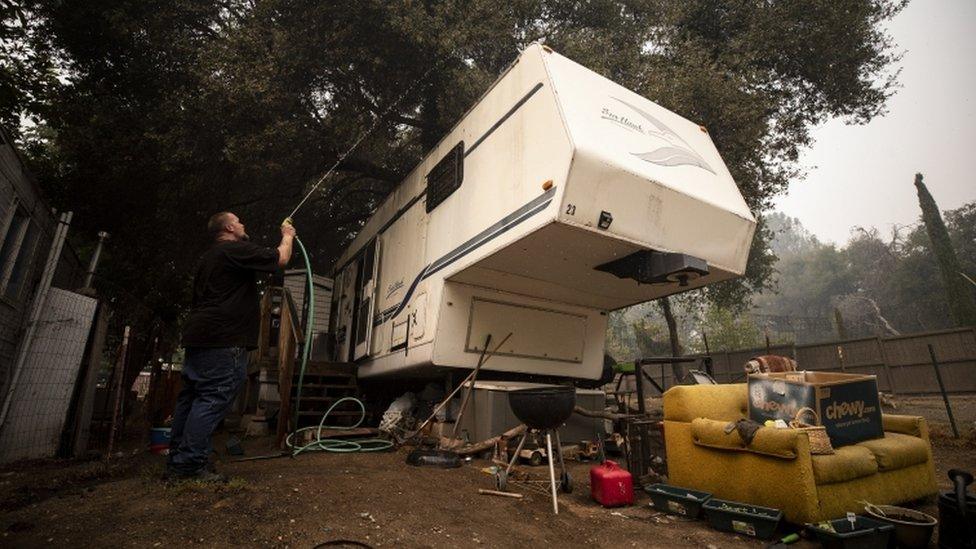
[332, 45, 756, 379]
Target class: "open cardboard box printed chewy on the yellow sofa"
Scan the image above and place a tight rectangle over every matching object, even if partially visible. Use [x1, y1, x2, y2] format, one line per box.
[749, 372, 884, 447]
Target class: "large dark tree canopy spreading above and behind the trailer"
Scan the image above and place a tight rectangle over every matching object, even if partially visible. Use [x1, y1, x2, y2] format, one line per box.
[0, 0, 904, 336]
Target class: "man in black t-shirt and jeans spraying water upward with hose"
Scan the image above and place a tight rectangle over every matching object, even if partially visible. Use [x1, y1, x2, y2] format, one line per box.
[166, 212, 295, 481]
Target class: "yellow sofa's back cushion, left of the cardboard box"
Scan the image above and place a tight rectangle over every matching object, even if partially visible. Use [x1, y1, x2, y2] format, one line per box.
[664, 383, 749, 422]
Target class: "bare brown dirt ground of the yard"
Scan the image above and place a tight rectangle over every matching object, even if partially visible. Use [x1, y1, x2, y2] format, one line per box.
[0, 396, 976, 548]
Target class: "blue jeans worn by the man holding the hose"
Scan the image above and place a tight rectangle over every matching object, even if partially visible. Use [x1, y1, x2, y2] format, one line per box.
[167, 347, 247, 474]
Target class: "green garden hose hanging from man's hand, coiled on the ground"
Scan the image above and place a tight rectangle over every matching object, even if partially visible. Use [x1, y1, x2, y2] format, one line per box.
[285, 236, 393, 456]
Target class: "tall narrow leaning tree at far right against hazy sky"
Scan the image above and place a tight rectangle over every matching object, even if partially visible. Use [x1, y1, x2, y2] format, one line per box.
[915, 173, 976, 327]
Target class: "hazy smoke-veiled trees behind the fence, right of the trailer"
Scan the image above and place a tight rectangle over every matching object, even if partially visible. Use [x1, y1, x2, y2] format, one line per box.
[755, 197, 976, 341]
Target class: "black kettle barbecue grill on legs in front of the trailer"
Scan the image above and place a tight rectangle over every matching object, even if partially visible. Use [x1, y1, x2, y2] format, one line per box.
[495, 386, 576, 514]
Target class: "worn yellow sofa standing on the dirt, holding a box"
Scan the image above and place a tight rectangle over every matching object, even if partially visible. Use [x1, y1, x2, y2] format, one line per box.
[664, 383, 937, 523]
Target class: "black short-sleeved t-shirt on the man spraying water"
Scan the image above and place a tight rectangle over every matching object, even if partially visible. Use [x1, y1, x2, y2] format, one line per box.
[183, 241, 278, 349]
